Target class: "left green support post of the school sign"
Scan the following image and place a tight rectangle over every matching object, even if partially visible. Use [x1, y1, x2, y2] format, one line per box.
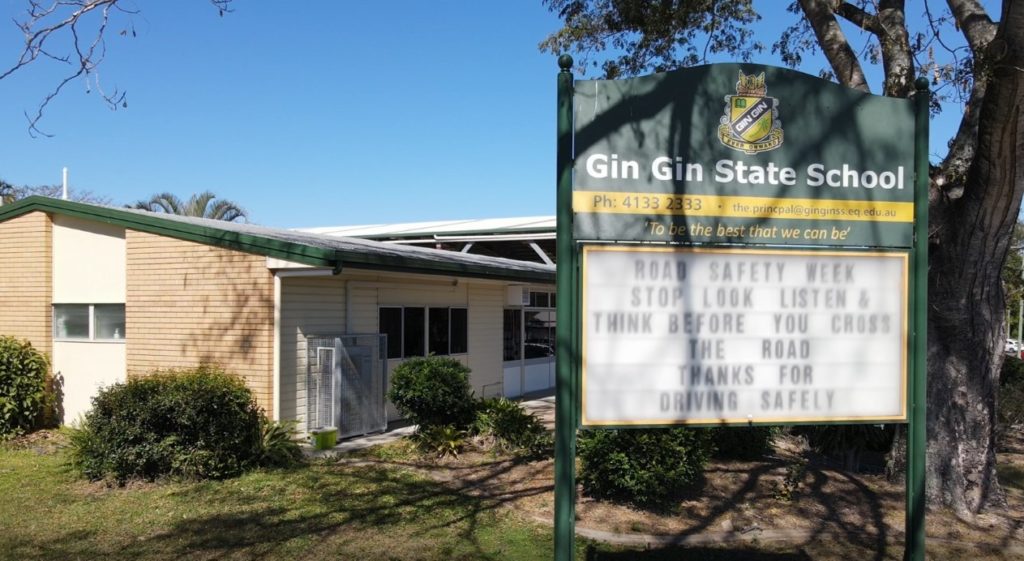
[555, 54, 577, 561]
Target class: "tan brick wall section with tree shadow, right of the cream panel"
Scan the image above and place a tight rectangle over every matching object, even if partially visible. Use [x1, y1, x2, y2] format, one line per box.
[125, 230, 273, 413]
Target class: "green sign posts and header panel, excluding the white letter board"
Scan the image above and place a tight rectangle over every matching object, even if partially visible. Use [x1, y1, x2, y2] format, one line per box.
[554, 55, 930, 561]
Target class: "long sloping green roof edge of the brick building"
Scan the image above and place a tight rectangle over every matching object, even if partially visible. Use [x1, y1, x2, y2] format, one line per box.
[0, 197, 555, 283]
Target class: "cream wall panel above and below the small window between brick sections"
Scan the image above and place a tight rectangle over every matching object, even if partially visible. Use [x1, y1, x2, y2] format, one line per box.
[53, 215, 125, 423]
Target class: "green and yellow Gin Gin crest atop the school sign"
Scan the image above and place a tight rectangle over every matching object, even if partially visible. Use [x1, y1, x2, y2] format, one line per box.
[718, 71, 782, 154]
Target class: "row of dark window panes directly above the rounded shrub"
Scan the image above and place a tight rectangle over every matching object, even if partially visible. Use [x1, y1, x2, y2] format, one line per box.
[378, 306, 469, 358]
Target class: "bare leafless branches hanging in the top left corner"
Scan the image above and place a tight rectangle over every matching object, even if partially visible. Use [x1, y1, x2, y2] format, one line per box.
[0, 0, 231, 136]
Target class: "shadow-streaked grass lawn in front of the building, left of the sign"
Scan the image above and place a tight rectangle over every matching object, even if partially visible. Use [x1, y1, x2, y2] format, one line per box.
[0, 438, 552, 561]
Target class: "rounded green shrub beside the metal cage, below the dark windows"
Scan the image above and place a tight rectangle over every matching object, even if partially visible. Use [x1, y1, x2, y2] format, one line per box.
[387, 356, 475, 429]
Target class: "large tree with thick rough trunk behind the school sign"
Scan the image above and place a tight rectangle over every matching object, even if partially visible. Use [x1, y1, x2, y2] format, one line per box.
[541, 0, 1024, 516]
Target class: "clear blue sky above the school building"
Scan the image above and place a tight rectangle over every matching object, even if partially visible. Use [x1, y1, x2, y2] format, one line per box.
[0, 0, 997, 227]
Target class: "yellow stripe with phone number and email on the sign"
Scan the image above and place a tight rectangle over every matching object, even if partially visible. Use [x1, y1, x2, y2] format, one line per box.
[572, 190, 913, 223]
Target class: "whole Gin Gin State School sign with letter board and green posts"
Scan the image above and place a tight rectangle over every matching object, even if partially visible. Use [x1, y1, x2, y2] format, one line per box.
[555, 57, 928, 559]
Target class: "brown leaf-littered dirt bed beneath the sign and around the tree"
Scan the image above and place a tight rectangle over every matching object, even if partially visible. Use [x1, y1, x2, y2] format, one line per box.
[342, 429, 1024, 557]
